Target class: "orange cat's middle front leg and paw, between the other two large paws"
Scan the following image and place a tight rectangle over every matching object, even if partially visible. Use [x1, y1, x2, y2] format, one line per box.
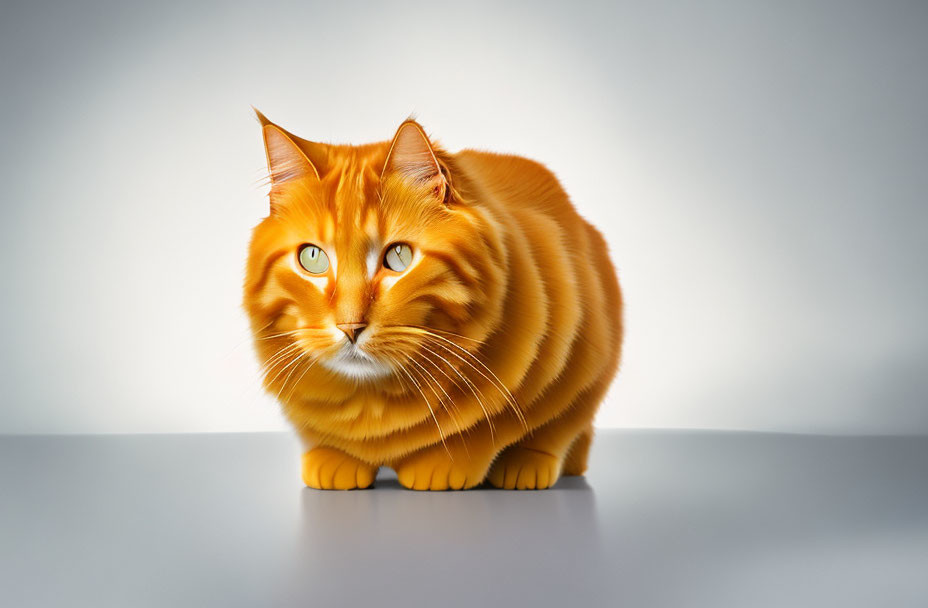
[393, 424, 499, 490]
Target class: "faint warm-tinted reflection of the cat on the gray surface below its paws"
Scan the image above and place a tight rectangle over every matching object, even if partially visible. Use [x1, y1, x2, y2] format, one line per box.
[282, 469, 603, 605]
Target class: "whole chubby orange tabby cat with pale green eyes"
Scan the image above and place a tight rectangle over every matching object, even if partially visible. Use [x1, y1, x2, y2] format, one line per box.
[244, 113, 622, 490]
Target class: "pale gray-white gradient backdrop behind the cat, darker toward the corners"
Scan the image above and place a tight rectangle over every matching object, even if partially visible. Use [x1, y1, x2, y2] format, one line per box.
[0, 0, 928, 433]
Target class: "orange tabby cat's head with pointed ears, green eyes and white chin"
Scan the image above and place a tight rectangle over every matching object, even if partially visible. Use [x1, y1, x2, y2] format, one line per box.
[245, 114, 505, 384]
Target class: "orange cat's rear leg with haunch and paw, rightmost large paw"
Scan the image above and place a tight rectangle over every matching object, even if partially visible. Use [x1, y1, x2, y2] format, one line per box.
[487, 377, 611, 490]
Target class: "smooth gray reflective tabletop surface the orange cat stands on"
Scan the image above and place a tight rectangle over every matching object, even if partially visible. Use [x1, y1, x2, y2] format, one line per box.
[0, 432, 928, 607]
